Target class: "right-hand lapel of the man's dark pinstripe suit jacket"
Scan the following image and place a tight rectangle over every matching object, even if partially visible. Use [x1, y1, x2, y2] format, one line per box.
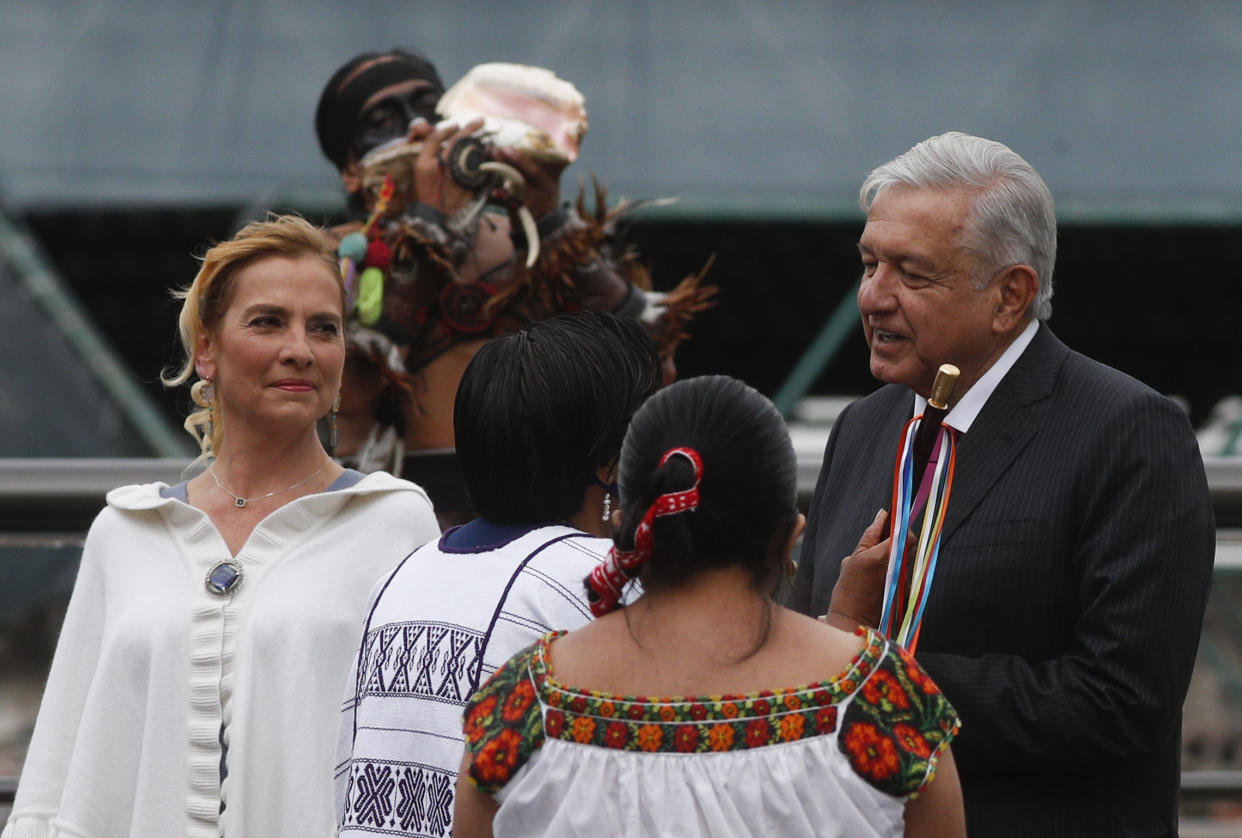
[943, 324, 1069, 541]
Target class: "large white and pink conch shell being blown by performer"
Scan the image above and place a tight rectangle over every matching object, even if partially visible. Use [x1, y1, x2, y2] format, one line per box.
[436, 63, 587, 163]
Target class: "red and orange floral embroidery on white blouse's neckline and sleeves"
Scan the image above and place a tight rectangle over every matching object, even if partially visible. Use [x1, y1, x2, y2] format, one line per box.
[465, 632, 956, 795]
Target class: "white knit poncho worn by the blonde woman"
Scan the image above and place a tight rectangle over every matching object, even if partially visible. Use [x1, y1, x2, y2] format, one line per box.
[4, 473, 438, 838]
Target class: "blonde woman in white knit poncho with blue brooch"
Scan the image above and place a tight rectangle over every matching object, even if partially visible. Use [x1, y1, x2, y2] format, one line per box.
[2, 217, 438, 838]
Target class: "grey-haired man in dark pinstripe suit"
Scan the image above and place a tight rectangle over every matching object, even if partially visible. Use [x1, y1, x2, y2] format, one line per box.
[790, 133, 1215, 838]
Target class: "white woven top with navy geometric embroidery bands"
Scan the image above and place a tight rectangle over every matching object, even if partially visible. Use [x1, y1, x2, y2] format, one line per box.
[337, 525, 611, 838]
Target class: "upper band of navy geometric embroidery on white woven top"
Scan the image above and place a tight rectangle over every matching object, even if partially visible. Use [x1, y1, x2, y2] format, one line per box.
[359, 622, 483, 704]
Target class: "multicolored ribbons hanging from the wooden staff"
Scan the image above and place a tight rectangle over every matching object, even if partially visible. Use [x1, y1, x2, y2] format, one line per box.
[879, 416, 958, 652]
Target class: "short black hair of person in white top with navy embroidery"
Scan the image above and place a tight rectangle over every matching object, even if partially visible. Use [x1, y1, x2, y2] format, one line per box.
[453, 312, 661, 524]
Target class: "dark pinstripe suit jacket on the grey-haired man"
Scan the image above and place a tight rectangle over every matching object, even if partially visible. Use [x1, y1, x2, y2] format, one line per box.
[790, 325, 1215, 838]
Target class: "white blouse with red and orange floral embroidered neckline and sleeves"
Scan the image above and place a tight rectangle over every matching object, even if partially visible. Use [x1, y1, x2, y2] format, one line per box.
[465, 632, 958, 838]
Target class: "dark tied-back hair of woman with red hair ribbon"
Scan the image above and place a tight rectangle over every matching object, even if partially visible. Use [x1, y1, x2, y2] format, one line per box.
[616, 375, 797, 592]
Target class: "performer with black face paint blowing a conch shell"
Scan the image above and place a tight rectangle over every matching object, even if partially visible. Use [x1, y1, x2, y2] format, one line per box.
[315, 50, 715, 523]
